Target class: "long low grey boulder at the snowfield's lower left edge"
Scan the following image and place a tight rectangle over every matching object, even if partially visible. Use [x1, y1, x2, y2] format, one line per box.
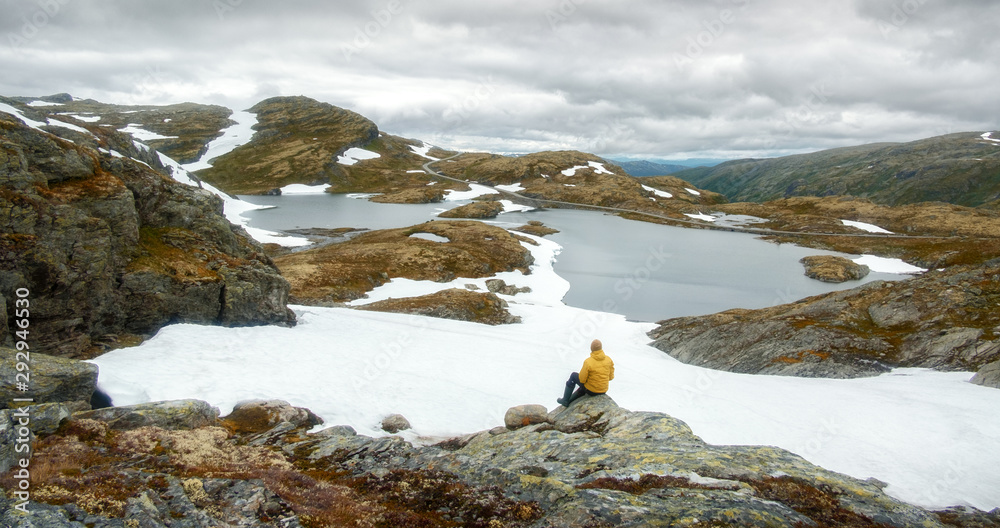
[73, 400, 219, 430]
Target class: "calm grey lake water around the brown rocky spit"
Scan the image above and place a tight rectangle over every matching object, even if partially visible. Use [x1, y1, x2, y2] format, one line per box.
[241, 194, 906, 322]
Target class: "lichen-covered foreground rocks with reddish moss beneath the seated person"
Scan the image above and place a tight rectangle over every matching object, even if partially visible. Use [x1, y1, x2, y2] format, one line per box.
[0, 396, 1000, 528]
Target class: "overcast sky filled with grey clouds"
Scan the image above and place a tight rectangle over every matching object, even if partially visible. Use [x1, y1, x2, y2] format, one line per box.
[0, 0, 1000, 158]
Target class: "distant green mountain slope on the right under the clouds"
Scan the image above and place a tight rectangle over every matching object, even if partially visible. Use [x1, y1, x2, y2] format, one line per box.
[674, 132, 1000, 207]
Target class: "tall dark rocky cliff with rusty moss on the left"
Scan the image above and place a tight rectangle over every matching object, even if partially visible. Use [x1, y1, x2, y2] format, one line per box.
[0, 107, 294, 357]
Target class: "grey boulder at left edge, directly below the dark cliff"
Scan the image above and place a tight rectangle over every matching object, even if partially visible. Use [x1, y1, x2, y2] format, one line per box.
[0, 347, 97, 409]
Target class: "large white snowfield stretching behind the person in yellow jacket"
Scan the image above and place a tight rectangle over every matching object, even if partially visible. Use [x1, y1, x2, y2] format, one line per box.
[93, 229, 1000, 510]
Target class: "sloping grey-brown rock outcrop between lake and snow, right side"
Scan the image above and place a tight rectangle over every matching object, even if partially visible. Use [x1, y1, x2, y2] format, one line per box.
[649, 261, 1000, 379]
